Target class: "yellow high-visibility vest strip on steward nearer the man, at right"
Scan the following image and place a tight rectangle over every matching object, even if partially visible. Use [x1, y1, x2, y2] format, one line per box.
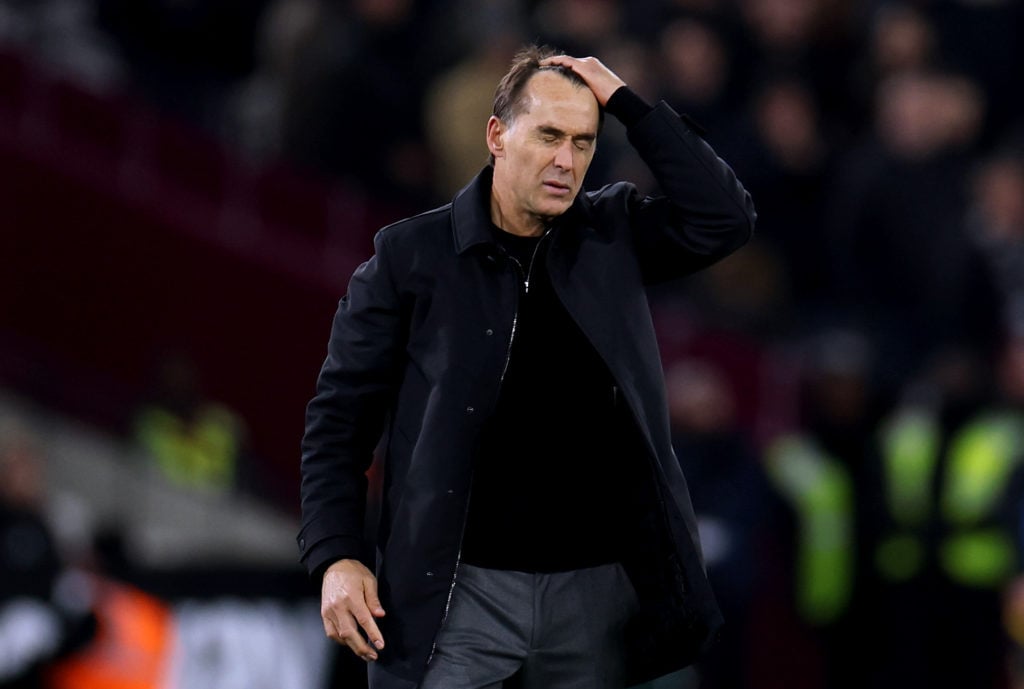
[765, 434, 854, 625]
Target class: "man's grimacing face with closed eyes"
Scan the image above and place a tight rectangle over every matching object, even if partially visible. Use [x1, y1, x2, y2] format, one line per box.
[487, 71, 598, 219]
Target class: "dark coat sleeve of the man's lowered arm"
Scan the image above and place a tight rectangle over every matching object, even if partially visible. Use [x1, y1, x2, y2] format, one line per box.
[297, 230, 402, 577]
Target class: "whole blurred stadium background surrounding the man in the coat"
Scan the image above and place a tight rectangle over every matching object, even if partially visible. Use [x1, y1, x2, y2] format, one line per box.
[6, 0, 1024, 689]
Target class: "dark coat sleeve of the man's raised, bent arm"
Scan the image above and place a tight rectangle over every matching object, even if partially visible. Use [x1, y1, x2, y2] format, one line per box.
[609, 92, 757, 283]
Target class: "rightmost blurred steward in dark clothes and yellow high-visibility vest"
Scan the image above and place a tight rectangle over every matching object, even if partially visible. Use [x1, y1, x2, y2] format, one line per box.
[864, 342, 1024, 689]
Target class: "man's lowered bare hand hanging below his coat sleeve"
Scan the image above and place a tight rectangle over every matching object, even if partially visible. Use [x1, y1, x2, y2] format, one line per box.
[321, 560, 384, 660]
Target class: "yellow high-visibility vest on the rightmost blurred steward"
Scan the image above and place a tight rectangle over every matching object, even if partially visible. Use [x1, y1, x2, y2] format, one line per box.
[874, 410, 1024, 588]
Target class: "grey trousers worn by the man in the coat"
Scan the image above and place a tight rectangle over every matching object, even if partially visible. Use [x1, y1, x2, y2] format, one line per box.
[411, 564, 637, 689]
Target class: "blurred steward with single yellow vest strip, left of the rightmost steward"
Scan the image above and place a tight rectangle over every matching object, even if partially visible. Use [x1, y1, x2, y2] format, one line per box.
[758, 327, 881, 689]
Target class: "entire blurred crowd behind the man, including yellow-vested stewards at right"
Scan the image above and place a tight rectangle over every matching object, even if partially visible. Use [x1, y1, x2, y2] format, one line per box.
[0, 0, 1024, 689]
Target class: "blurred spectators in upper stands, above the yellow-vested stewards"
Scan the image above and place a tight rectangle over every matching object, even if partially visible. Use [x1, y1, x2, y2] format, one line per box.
[0, 0, 1024, 376]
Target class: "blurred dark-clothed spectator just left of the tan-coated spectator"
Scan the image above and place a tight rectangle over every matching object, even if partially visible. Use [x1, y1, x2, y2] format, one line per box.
[284, 0, 434, 214]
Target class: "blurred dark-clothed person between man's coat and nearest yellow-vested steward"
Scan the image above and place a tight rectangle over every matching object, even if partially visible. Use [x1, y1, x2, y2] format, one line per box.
[667, 359, 769, 689]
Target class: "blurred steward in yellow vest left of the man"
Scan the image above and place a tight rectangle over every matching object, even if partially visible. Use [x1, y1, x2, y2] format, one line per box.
[134, 354, 246, 492]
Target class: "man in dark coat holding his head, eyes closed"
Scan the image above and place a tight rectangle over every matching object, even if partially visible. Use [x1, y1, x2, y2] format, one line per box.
[298, 47, 755, 689]
